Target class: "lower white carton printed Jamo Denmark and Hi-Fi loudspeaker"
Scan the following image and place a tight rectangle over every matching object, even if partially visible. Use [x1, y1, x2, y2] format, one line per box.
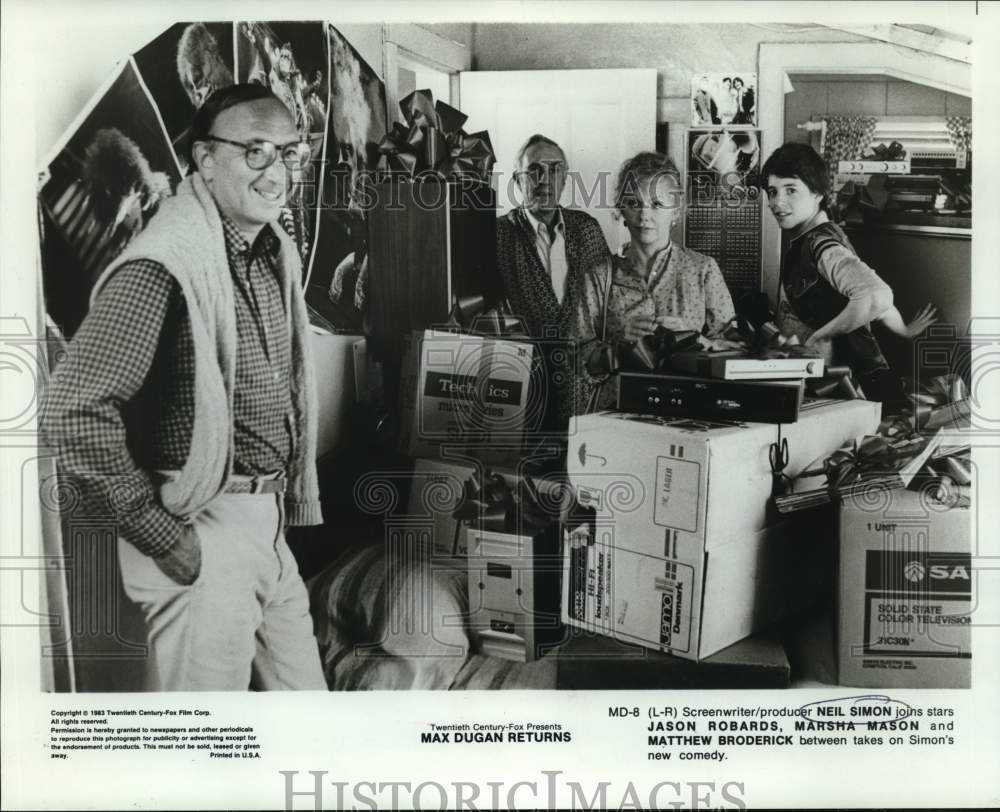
[562, 520, 835, 660]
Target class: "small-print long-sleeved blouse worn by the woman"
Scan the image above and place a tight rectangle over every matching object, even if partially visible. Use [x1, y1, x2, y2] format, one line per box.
[573, 239, 735, 406]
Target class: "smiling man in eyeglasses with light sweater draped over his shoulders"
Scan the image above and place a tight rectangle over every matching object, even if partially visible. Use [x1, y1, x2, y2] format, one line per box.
[43, 85, 326, 690]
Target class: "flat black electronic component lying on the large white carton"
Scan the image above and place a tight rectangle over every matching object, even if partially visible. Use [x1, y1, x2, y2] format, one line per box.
[618, 372, 804, 423]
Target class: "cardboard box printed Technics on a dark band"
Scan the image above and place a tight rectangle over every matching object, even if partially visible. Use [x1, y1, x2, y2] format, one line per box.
[399, 330, 543, 464]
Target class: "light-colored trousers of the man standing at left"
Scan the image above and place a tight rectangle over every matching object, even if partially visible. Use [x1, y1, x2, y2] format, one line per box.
[118, 494, 327, 691]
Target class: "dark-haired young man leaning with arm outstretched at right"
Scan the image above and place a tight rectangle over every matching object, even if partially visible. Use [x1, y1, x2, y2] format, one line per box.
[761, 144, 933, 414]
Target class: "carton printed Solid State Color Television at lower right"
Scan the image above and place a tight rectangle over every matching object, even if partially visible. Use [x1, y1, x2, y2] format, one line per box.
[837, 489, 974, 688]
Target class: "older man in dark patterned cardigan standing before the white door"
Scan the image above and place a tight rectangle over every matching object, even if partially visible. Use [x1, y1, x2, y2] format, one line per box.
[497, 134, 610, 429]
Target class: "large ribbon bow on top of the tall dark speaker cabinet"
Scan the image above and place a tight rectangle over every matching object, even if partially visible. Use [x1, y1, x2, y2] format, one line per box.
[378, 90, 495, 181]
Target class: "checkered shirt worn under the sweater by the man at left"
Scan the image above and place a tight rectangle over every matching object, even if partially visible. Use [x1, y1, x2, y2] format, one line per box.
[44, 217, 292, 556]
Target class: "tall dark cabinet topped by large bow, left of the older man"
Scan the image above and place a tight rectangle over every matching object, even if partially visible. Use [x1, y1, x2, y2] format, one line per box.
[367, 179, 503, 357]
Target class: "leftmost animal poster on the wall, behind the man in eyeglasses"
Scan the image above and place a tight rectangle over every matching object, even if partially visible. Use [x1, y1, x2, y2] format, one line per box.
[38, 60, 181, 338]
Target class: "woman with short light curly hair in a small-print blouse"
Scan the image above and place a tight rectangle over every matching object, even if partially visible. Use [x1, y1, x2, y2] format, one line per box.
[575, 152, 735, 412]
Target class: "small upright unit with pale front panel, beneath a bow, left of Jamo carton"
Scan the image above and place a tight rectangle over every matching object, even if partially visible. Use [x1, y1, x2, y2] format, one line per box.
[468, 523, 563, 662]
